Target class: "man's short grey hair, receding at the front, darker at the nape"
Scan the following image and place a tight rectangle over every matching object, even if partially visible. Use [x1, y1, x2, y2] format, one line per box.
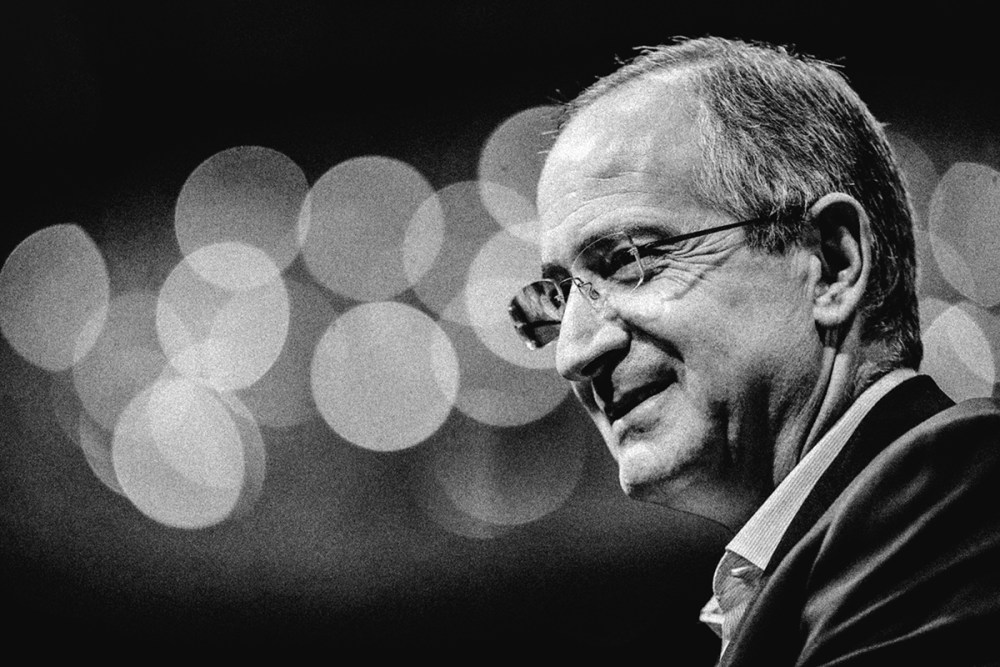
[565, 37, 923, 384]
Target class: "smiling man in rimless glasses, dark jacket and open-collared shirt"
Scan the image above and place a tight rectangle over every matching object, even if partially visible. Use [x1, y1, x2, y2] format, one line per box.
[511, 38, 1000, 666]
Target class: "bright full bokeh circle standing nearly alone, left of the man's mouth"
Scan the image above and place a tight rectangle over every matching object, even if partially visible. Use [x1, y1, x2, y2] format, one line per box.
[310, 302, 458, 451]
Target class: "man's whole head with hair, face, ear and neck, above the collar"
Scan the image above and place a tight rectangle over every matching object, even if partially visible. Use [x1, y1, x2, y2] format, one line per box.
[539, 38, 921, 525]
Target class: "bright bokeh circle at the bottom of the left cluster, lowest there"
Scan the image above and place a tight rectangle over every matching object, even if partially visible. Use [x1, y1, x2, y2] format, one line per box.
[112, 376, 260, 528]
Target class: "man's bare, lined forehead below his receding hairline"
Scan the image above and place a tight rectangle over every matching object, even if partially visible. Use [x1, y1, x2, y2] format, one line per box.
[538, 74, 701, 251]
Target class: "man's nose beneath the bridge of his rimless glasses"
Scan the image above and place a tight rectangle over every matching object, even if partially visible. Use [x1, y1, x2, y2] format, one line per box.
[556, 290, 629, 382]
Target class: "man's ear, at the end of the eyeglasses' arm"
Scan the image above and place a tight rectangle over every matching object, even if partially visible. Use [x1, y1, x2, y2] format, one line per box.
[808, 192, 872, 329]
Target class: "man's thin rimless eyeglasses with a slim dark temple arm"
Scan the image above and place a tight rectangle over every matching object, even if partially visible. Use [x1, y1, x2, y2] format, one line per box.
[508, 217, 773, 350]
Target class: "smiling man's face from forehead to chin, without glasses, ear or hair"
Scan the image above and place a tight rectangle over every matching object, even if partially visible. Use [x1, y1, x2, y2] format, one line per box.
[539, 80, 821, 525]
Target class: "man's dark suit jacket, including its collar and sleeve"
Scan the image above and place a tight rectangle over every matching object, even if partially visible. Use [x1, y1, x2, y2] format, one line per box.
[721, 376, 1000, 667]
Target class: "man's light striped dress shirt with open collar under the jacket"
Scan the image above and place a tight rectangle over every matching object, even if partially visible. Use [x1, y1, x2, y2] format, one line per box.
[700, 369, 916, 655]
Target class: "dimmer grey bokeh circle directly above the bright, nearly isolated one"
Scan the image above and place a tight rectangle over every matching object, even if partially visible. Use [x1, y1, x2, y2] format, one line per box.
[298, 156, 437, 301]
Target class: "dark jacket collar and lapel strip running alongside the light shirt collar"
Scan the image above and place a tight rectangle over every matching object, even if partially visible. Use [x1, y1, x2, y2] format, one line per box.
[765, 375, 955, 575]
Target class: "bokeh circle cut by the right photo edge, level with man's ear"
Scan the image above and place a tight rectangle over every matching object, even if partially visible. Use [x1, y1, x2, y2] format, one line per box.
[930, 162, 1000, 308]
